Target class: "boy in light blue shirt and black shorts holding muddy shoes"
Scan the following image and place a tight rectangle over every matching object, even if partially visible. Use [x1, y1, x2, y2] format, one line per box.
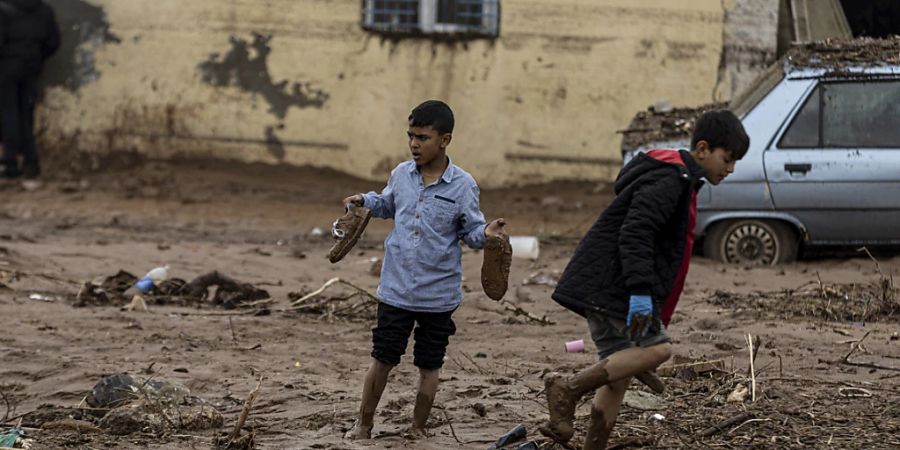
[344, 100, 505, 439]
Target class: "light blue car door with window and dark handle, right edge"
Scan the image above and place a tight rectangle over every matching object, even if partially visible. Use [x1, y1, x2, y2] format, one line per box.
[764, 77, 900, 244]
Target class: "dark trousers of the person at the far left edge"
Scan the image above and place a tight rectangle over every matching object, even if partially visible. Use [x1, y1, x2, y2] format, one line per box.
[0, 77, 38, 173]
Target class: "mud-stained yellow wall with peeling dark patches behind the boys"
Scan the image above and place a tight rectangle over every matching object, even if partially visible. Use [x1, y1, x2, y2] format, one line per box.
[40, 0, 723, 186]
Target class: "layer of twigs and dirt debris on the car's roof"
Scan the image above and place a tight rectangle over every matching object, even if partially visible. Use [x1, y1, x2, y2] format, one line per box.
[784, 36, 900, 69]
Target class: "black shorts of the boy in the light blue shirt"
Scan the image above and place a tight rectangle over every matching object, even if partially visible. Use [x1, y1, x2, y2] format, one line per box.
[372, 302, 456, 370]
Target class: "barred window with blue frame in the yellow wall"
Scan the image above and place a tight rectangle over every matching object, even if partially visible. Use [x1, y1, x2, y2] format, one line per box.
[362, 0, 500, 37]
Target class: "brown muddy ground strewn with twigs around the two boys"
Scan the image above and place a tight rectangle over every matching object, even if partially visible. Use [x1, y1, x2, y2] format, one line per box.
[0, 157, 900, 449]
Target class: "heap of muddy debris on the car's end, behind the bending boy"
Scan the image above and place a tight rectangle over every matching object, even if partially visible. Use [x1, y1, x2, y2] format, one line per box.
[619, 102, 728, 152]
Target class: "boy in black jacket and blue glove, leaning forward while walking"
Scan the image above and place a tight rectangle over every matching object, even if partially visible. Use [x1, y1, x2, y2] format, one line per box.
[540, 111, 750, 450]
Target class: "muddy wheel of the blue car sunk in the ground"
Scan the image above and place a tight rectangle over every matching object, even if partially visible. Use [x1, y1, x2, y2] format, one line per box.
[703, 219, 798, 266]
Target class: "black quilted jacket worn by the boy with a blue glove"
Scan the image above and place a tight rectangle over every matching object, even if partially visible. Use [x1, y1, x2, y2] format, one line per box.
[553, 150, 704, 320]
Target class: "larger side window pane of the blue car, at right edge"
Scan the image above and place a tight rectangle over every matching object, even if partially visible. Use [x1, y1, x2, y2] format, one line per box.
[822, 81, 900, 148]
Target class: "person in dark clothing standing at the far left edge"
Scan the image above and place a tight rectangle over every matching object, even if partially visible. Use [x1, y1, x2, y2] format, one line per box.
[0, 0, 59, 178]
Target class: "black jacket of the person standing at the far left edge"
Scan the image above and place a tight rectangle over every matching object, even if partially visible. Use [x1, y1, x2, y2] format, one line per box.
[0, 0, 59, 78]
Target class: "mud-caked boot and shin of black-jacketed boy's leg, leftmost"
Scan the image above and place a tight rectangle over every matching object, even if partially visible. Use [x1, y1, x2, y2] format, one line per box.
[539, 359, 609, 443]
